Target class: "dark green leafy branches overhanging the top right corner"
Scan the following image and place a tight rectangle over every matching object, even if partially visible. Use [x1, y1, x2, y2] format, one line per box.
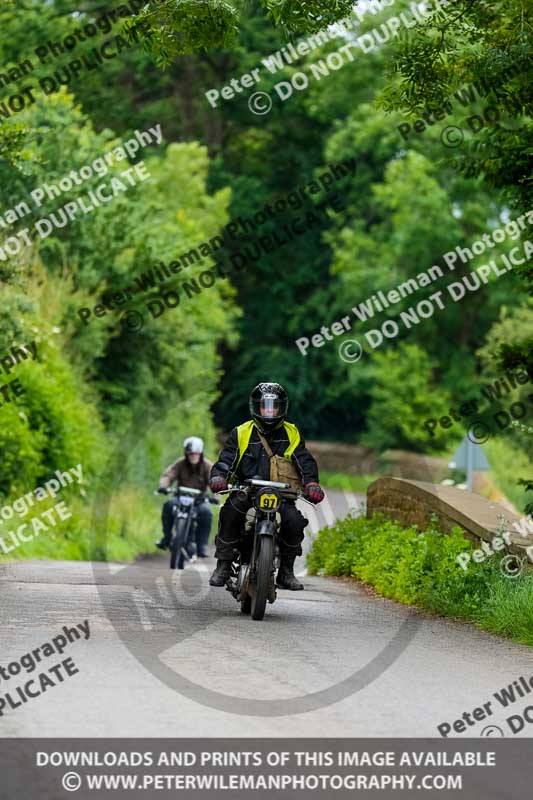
[383, 0, 533, 208]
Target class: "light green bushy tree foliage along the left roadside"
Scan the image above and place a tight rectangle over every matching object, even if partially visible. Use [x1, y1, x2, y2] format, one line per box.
[0, 91, 234, 500]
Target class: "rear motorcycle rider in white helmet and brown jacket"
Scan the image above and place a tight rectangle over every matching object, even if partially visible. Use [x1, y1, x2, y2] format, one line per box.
[156, 436, 213, 558]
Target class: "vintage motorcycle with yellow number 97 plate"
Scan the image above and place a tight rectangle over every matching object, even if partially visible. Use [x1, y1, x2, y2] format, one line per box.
[218, 478, 303, 620]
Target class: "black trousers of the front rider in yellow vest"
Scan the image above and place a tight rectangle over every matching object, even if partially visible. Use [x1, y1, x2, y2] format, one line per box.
[215, 495, 309, 560]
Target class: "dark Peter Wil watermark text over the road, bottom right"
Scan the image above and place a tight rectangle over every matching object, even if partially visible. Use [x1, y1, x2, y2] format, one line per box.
[437, 675, 533, 739]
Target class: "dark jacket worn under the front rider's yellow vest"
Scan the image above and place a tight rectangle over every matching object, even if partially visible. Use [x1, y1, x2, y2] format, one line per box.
[211, 426, 318, 485]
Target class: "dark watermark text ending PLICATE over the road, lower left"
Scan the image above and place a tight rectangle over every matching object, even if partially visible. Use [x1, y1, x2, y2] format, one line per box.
[0, 619, 91, 717]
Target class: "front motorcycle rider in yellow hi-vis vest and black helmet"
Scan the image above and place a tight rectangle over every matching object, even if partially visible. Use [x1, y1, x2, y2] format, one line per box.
[209, 382, 324, 591]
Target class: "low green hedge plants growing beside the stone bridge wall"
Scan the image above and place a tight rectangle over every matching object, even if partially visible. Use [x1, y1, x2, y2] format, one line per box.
[308, 515, 533, 645]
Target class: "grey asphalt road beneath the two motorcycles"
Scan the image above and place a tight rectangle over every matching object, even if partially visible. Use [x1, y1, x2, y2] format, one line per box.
[0, 492, 533, 737]
